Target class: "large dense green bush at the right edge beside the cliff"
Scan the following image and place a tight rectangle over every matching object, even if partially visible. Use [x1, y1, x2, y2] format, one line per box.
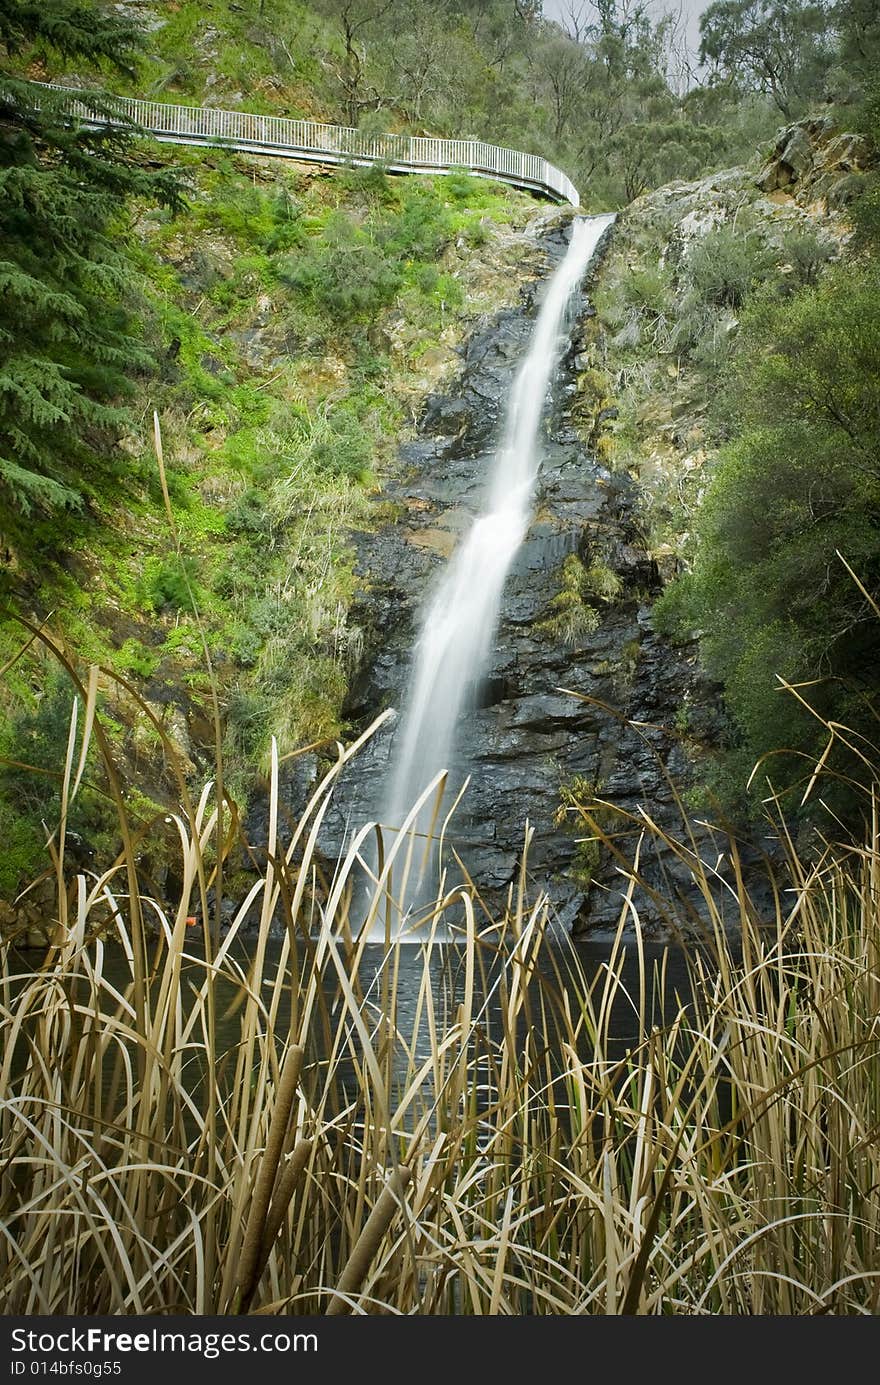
[658, 267, 880, 812]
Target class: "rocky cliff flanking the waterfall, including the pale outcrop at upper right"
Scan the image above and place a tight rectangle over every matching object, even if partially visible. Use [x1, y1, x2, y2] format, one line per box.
[304, 122, 875, 935]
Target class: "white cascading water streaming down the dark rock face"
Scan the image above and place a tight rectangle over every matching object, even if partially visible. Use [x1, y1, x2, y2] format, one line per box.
[381, 216, 614, 914]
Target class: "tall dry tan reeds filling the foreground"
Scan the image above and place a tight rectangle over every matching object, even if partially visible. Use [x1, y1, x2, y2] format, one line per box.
[0, 648, 880, 1314]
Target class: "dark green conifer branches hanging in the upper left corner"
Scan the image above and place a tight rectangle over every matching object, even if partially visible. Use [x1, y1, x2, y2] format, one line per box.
[0, 0, 179, 553]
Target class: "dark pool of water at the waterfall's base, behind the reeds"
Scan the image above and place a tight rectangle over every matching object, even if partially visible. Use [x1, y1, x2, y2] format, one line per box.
[6, 938, 720, 1135]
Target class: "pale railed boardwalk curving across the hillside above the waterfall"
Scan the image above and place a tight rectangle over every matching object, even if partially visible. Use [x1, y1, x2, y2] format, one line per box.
[35, 82, 581, 206]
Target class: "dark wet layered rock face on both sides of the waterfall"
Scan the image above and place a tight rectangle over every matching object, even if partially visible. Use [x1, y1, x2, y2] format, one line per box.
[306, 221, 720, 932]
